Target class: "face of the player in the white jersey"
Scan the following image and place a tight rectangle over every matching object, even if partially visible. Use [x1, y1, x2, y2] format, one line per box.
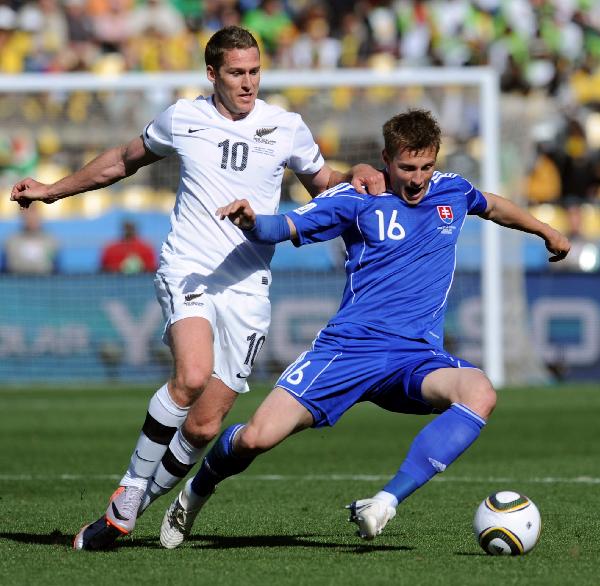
[206, 47, 260, 120]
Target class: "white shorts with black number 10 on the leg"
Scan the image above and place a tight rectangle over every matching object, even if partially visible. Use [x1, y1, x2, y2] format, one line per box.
[154, 275, 271, 393]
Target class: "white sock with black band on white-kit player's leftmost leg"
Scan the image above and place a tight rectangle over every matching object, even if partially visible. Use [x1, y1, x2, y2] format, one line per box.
[120, 384, 189, 489]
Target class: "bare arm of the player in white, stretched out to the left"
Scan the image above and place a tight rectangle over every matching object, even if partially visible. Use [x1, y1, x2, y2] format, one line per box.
[10, 136, 162, 208]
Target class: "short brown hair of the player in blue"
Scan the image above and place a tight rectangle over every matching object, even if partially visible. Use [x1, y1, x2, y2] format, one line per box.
[383, 110, 442, 157]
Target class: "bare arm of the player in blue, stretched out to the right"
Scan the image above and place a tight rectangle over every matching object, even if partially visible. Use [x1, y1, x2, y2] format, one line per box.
[480, 193, 571, 262]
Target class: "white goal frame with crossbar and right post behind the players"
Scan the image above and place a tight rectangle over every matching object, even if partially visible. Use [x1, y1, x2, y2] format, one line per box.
[0, 67, 506, 387]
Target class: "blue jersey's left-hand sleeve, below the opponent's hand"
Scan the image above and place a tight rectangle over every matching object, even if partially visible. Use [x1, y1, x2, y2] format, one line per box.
[286, 185, 364, 246]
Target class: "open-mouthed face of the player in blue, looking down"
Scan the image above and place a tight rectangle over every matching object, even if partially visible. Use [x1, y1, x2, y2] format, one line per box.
[383, 147, 437, 205]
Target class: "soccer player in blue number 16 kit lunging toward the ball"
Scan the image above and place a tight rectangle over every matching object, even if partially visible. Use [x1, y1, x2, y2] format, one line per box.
[160, 110, 570, 548]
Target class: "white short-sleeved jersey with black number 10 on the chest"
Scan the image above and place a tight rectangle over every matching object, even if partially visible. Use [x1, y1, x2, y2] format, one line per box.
[143, 96, 324, 295]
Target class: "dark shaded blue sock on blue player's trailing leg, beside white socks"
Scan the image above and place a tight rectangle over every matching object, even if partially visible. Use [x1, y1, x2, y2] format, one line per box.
[191, 423, 254, 496]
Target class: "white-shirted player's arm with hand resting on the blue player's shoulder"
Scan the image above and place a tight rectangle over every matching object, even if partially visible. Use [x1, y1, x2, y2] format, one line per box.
[298, 163, 385, 197]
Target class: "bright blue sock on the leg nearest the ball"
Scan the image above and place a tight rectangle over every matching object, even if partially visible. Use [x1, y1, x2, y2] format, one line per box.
[383, 403, 485, 502]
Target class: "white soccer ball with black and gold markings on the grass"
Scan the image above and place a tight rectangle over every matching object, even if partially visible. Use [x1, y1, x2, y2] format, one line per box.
[473, 490, 542, 555]
